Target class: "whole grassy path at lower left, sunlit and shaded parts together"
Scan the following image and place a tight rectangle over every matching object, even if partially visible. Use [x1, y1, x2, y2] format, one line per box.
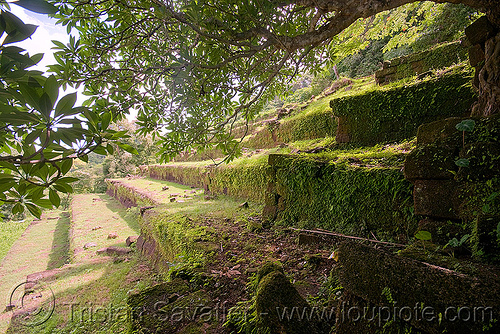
[0, 194, 155, 334]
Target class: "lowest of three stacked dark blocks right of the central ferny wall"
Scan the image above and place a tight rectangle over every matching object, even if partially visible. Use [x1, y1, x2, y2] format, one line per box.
[413, 180, 460, 219]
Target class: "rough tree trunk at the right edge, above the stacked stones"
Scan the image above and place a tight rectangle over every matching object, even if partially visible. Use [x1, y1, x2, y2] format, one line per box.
[472, 32, 500, 116]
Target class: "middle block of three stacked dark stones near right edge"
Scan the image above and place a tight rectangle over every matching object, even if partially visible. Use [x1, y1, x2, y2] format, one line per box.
[404, 144, 458, 181]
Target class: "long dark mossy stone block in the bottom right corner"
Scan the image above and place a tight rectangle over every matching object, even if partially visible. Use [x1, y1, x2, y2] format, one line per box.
[338, 242, 500, 334]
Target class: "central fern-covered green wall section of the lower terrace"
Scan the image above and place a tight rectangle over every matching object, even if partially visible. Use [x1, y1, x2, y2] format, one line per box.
[264, 154, 417, 241]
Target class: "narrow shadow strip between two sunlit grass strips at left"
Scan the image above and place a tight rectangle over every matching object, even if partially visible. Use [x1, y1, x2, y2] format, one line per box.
[47, 212, 71, 270]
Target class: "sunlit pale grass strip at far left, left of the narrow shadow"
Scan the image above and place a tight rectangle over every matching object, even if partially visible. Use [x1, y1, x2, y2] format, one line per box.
[0, 211, 69, 333]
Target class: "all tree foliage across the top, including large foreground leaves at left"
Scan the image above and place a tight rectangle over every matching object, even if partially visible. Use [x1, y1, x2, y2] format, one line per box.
[0, 0, 499, 215]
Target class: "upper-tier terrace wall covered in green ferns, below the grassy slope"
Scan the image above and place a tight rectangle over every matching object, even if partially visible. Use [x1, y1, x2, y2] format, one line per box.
[330, 66, 476, 145]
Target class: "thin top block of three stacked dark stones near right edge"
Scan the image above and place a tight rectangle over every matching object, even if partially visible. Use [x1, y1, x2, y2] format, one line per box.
[417, 117, 467, 145]
